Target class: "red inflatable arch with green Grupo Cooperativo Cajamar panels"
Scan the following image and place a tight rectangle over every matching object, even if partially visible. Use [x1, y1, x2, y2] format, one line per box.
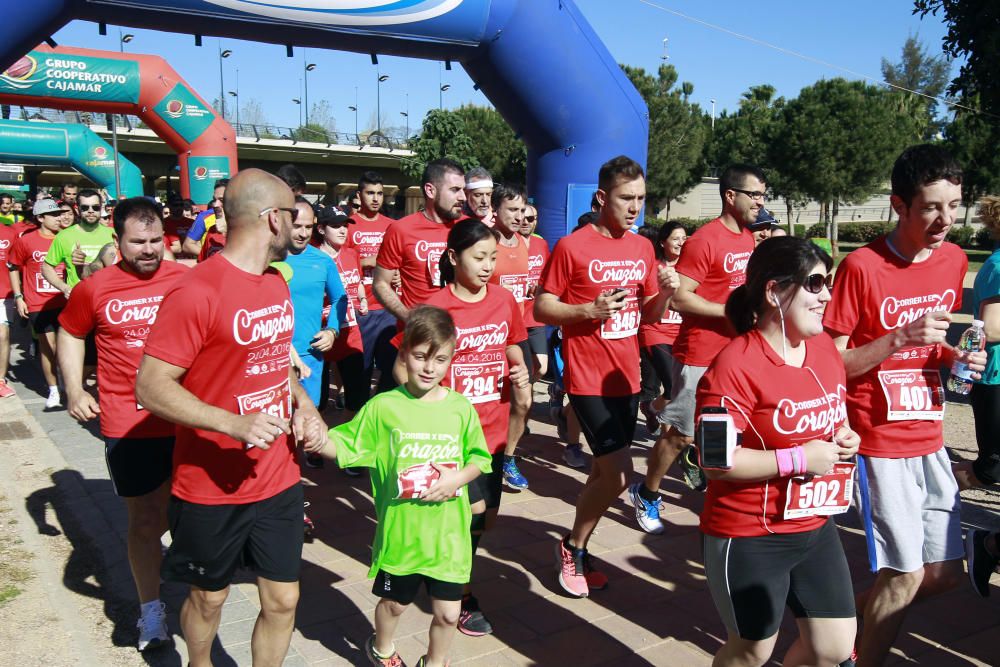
[0, 43, 236, 204]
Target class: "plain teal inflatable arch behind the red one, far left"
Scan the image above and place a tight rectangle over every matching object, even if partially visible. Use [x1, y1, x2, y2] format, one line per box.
[0, 120, 142, 197]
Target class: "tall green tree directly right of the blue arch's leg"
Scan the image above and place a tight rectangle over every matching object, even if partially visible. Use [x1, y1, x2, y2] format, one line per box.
[622, 65, 708, 216]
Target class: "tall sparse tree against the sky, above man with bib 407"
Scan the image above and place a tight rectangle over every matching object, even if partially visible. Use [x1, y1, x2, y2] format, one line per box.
[882, 35, 951, 140]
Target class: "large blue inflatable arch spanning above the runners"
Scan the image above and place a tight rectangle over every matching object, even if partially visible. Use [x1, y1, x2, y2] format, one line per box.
[0, 0, 648, 243]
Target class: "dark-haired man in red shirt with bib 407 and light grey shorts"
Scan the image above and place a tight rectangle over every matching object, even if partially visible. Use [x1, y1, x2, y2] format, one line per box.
[824, 144, 986, 667]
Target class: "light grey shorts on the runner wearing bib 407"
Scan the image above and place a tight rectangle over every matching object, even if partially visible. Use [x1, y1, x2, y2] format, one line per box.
[854, 447, 965, 572]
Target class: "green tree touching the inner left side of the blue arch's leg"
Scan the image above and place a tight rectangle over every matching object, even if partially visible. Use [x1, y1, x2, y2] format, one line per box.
[454, 105, 528, 184]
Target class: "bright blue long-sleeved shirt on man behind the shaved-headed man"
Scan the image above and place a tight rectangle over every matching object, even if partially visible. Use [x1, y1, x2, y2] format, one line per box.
[285, 246, 347, 359]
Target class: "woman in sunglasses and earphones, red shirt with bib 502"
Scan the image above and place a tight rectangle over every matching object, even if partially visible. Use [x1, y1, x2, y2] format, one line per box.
[695, 237, 860, 667]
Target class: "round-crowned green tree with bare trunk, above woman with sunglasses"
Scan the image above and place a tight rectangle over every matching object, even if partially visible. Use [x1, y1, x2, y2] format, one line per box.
[770, 78, 915, 251]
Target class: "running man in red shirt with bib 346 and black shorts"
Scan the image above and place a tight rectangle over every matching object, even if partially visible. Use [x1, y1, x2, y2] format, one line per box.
[535, 156, 677, 597]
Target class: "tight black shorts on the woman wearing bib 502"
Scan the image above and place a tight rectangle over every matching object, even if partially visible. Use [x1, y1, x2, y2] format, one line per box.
[702, 519, 855, 641]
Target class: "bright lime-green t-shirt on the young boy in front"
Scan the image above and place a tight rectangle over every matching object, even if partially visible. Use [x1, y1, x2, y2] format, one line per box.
[330, 386, 492, 584]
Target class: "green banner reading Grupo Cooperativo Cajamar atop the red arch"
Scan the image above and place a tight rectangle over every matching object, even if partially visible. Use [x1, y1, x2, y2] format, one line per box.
[0, 51, 139, 104]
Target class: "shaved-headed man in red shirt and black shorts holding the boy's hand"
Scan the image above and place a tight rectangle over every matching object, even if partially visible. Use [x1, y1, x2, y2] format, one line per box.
[136, 169, 326, 667]
